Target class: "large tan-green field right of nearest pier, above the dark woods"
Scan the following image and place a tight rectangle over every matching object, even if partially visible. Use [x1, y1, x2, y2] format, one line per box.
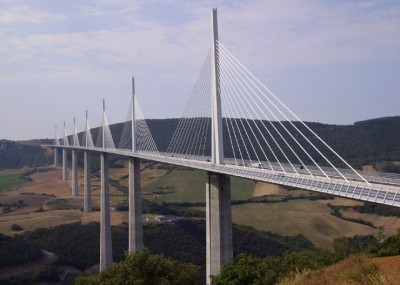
[232, 200, 378, 245]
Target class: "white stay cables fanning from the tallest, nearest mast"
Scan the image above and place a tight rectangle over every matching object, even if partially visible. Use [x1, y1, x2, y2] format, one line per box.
[167, 42, 368, 183]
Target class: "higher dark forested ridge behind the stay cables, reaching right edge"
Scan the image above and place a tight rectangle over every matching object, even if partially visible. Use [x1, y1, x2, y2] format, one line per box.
[86, 116, 400, 169]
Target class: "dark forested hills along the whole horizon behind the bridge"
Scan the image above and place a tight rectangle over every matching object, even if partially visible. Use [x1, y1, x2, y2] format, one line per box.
[0, 116, 400, 169]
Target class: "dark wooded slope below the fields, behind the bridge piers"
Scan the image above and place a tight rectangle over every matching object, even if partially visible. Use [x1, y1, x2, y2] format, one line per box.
[0, 220, 314, 284]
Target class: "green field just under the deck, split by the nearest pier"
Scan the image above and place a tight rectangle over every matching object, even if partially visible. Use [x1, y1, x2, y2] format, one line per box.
[143, 170, 254, 203]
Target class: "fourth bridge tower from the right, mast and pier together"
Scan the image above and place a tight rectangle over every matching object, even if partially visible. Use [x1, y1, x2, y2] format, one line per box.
[83, 111, 92, 213]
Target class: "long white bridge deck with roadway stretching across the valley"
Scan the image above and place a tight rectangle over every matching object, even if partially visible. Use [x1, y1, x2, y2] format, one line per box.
[55, 145, 400, 207]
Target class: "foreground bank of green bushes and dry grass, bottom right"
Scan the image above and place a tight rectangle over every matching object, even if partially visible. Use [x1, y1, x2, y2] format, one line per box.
[212, 229, 400, 285]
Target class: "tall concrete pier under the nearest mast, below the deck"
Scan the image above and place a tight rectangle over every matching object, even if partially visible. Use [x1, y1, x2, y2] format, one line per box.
[206, 172, 233, 284]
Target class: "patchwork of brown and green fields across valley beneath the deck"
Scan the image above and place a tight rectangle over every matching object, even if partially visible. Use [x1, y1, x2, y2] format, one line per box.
[0, 163, 400, 245]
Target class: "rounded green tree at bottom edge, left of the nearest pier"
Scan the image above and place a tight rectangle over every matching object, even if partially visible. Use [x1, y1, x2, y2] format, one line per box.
[76, 246, 200, 285]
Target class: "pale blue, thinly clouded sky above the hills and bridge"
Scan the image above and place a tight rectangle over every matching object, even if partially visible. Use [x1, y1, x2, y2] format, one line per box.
[0, 0, 400, 139]
